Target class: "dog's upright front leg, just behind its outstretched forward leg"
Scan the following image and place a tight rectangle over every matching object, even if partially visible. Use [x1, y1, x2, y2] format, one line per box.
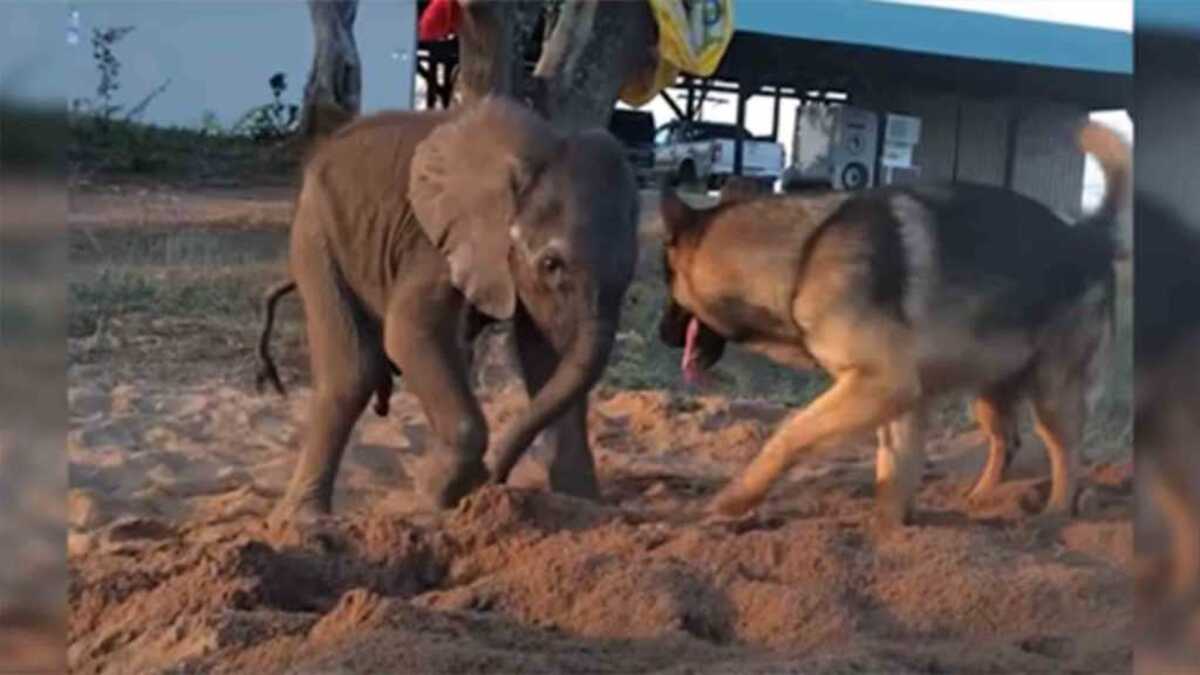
[875, 405, 926, 527]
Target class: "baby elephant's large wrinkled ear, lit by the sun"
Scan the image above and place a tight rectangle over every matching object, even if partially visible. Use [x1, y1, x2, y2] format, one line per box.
[408, 97, 559, 319]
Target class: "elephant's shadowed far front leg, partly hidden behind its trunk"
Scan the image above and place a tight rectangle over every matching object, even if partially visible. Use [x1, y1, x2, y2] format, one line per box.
[514, 311, 600, 500]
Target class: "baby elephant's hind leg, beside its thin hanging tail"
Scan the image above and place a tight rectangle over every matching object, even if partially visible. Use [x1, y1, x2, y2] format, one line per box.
[272, 247, 390, 519]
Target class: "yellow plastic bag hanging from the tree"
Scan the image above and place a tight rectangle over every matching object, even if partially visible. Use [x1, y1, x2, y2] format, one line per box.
[620, 0, 733, 106]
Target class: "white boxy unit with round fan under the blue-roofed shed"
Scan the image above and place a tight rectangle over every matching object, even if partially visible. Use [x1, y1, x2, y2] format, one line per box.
[785, 102, 880, 190]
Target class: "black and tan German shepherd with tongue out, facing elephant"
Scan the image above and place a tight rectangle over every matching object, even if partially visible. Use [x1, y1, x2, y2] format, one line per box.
[659, 125, 1130, 525]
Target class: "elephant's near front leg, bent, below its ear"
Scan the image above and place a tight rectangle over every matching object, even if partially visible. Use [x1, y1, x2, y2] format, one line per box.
[384, 281, 487, 508]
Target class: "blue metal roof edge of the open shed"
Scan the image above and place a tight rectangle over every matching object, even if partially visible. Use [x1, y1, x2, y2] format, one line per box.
[733, 0, 1133, 74]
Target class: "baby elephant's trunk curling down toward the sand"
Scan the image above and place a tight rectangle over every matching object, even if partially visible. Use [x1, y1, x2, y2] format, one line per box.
[492, 318, 617, 483]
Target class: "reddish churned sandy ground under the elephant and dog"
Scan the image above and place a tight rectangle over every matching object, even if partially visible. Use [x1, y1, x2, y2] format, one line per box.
[67, 181, 1134, 674]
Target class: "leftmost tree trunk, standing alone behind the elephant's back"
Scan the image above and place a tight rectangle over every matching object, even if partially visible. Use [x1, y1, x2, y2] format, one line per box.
[300, 0, 362, 137]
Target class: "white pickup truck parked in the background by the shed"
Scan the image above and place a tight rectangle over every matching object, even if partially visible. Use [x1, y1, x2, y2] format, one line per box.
[654, 120, 785, 190]
